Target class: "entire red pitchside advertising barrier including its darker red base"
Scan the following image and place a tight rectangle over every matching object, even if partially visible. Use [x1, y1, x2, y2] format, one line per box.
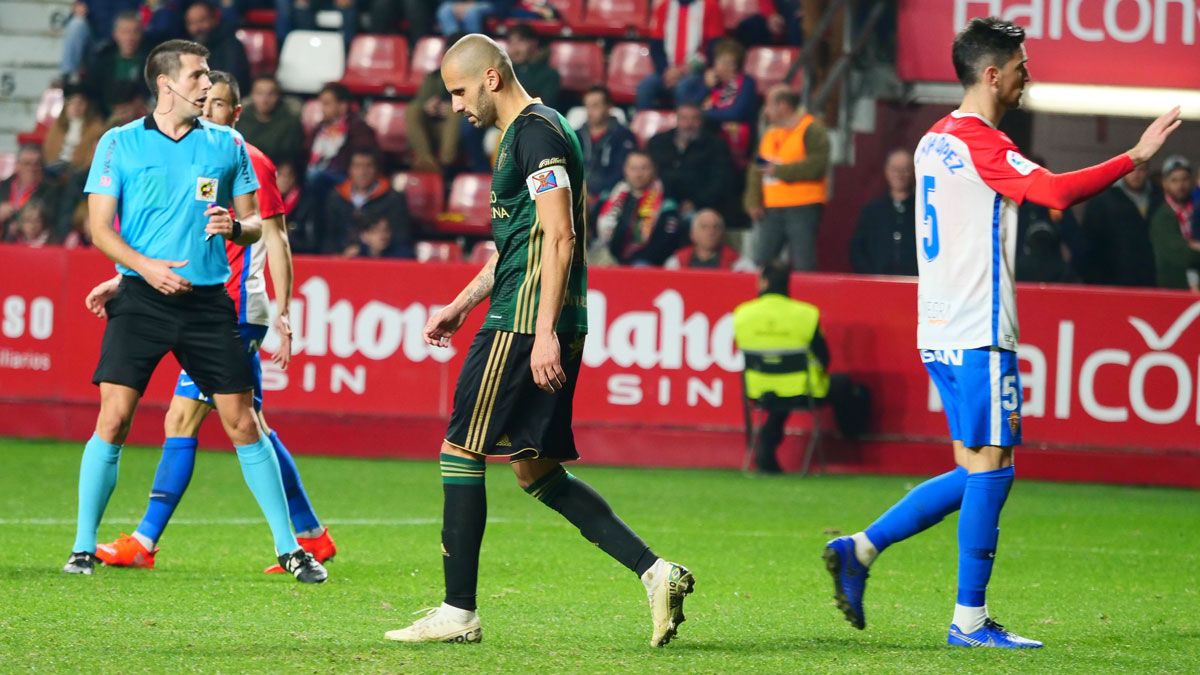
[0, 246, 1200, 488]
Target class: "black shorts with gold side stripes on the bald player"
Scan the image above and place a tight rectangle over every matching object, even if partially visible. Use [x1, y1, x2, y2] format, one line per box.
[445, 328, 584, 461]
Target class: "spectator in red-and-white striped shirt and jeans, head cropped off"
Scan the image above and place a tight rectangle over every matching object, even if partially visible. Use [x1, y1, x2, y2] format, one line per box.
[637, 0, 725, 110]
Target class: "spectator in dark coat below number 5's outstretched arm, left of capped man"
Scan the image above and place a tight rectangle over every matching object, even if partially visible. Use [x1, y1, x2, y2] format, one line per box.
[1084, 163, 1163, 286]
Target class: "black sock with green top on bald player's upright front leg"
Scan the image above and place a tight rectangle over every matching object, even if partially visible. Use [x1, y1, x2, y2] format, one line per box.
[442, 453, 487, 611]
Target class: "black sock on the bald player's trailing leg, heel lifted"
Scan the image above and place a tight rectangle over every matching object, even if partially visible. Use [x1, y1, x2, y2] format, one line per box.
[526, 466, 658, 577]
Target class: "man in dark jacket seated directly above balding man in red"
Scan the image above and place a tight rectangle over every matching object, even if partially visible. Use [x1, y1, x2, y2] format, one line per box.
[646, 103, 734, 219]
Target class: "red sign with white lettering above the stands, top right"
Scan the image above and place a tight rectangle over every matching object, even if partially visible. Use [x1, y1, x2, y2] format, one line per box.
[896, 0, 1200, 89]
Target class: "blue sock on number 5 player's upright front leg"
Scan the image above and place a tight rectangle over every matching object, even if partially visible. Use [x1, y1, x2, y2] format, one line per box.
[958, 466, 1015, 607]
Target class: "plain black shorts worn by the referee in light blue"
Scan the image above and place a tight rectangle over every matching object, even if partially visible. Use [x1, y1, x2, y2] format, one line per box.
[91, 276, 254, 394]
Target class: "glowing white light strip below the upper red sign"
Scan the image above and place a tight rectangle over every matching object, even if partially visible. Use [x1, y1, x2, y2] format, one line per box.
[1021, 82, 1200, 120]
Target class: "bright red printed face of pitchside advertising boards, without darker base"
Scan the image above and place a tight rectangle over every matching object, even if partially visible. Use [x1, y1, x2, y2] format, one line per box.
[0, 246, 1200, 482]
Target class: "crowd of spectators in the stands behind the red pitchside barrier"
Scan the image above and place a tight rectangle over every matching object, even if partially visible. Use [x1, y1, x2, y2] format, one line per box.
[0, 0, 1200, 292]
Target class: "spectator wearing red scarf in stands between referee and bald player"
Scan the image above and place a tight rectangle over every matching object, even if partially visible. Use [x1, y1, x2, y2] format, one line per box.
[305, 82, 378, 190]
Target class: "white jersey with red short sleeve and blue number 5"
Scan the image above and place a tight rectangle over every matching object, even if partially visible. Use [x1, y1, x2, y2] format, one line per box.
[913, 110, 1045, 351]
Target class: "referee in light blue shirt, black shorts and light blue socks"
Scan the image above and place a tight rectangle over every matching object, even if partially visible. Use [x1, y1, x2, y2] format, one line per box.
[64, 40, 326, 583]
